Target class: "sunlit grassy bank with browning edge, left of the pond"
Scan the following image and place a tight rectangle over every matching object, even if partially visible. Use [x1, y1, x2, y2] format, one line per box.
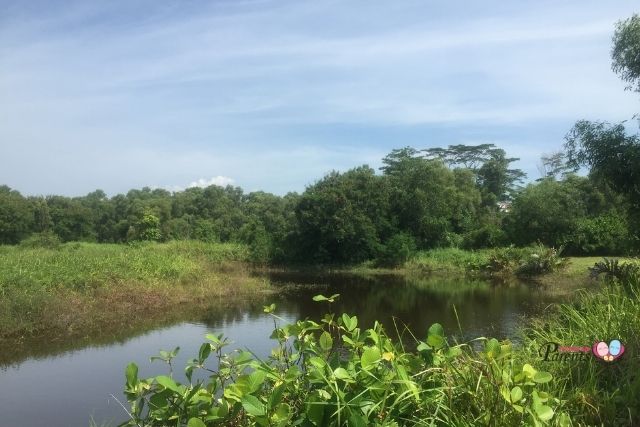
[0, 242, 265, 346]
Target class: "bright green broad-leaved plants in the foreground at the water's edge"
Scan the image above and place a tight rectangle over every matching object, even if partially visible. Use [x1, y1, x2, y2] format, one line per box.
[117, 295, 570, 427]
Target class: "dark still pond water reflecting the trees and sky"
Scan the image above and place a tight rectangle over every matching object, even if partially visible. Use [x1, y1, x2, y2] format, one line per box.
[0, 273, 560, 427]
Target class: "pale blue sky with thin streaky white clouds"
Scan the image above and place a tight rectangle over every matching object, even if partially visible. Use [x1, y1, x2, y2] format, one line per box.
[0, 0, 640, 195]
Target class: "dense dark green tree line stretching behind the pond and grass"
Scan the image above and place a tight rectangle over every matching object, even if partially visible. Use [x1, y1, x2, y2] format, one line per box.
[0, 15, 640, 264]
